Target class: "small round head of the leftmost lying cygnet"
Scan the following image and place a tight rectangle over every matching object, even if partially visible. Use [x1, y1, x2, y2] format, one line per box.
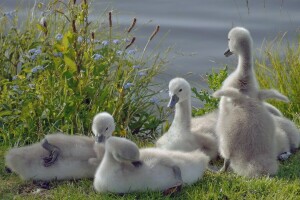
[92, 112, 115, 143]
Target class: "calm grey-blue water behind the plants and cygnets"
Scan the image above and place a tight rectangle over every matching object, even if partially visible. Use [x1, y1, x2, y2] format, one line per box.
[0, 0, 300, 85]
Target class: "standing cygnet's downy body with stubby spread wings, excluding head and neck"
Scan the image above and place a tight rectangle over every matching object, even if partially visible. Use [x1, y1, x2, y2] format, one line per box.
[213, 88, 288, 177]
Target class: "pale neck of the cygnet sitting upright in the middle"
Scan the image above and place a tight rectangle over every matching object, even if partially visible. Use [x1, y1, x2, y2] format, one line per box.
[172, 99, 192, 132]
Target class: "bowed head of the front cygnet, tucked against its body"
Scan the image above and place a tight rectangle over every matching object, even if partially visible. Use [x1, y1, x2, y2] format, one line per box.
[105, 137, 140, 163]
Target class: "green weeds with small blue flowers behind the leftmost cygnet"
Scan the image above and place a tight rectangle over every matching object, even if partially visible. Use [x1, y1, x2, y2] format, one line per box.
[0, 0, 167, 145]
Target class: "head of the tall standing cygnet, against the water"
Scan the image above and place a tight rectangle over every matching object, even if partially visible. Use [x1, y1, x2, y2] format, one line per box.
[224, 27, 252, 57]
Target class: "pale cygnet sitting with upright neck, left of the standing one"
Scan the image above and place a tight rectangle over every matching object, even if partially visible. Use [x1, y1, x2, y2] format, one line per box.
[156, 78, 218, 159]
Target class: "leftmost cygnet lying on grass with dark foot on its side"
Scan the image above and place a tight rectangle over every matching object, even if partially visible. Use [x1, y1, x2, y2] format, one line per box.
[6, 112, 115, 181]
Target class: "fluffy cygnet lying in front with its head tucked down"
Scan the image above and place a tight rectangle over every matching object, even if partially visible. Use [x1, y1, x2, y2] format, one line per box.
[94, 137, 209, 193]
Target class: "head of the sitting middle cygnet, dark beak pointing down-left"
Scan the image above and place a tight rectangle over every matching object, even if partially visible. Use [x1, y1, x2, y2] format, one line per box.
[168, 78, 191, 108]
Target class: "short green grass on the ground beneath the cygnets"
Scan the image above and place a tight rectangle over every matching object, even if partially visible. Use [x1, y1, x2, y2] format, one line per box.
[0, 147, 300, 200]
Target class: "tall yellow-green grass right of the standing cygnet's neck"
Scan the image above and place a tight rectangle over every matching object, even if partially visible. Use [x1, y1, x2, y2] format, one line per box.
[255, 37, 300, 124]
